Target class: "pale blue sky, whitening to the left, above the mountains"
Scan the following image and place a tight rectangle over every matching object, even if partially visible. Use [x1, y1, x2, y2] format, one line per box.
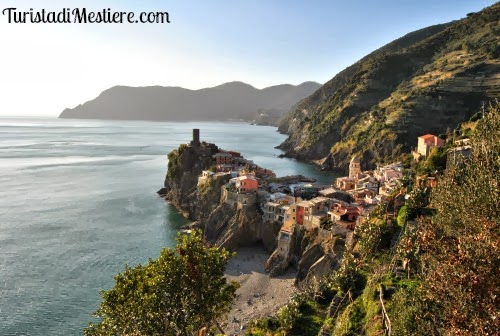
[0, 0, 495, 116]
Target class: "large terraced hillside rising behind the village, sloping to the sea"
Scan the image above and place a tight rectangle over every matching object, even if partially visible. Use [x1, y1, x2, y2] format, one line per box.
[279, 3, 500, 171]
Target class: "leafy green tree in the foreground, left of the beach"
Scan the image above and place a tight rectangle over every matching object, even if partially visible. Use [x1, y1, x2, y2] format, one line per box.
[85, 231, 238, 336]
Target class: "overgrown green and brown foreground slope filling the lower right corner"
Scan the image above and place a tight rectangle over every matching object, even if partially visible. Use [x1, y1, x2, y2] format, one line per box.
[252, 103, 500, 336]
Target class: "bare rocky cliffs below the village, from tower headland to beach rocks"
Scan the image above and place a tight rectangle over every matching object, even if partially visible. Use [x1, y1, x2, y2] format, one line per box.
[162, 143, 347, 286]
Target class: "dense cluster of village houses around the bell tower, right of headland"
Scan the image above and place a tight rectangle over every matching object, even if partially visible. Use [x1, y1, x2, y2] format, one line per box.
[261, 156, 403, 253]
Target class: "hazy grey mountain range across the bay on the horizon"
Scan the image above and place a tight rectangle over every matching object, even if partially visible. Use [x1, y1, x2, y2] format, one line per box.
[59, 82, 321, 121]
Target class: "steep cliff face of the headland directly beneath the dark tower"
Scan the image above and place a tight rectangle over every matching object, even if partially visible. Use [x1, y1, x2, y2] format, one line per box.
[160, 143, 280, 251]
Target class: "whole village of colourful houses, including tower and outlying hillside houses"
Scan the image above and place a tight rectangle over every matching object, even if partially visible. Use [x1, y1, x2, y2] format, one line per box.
[193, 130, 470, 260]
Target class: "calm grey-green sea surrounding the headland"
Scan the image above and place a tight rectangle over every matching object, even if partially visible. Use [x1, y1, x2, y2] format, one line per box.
[0, 118, 332, 336]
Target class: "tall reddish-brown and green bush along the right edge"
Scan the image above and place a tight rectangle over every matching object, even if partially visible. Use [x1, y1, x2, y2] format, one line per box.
[417, 103, 500, 335]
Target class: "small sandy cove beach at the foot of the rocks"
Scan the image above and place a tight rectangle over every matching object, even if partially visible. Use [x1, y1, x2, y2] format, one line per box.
[222, 248, 296, 335]
